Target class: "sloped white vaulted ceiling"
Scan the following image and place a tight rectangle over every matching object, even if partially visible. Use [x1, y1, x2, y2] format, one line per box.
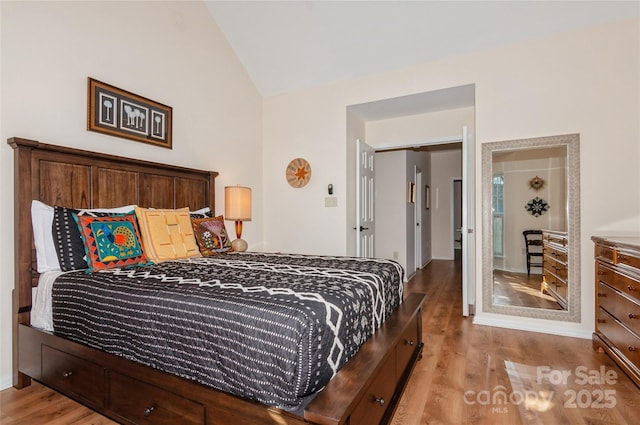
[206, 1, 640, 96]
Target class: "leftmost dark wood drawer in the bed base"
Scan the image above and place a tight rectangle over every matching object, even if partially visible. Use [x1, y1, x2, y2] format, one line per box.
[42, 345, 105, 407]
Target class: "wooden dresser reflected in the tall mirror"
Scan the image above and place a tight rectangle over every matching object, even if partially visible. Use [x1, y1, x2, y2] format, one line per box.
[542, 230, 569, 309]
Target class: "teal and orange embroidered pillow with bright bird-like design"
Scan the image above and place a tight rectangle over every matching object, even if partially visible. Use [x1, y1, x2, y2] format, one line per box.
[74, 214, 148, 270]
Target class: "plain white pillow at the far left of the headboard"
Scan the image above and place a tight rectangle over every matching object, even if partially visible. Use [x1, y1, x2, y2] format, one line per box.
[31, 200, 60, 273]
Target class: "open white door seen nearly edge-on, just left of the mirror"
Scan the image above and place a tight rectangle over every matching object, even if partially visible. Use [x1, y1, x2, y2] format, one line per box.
[461, 126, 475, 316]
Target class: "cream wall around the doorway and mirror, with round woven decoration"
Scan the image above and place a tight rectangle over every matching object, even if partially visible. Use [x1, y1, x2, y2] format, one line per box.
[263, 19, 640, 337]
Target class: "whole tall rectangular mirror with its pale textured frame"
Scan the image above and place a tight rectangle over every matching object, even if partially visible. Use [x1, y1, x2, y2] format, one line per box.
[482, 134, 580, 322]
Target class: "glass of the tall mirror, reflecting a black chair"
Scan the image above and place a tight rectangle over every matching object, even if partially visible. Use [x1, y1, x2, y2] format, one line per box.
[492, 146, 567, 310]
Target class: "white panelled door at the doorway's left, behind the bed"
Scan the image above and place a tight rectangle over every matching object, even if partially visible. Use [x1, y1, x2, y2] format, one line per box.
[355, 140, 375, 257]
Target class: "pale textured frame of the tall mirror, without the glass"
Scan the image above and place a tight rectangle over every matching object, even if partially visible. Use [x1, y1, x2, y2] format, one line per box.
[482, 134, 581, 322]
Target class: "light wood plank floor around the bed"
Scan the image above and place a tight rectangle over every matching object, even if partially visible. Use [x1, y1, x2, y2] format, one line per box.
[0, 260, 640, 425]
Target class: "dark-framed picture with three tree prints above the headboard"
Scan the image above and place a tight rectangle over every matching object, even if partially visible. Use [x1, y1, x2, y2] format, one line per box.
[87, 77, 173, 149]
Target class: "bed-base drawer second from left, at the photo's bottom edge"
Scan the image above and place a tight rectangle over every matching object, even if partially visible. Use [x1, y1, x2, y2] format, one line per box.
[109, 373, 205, 425]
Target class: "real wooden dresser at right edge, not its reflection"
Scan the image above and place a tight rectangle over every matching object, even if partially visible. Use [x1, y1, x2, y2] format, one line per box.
[591, 237, 640, 386]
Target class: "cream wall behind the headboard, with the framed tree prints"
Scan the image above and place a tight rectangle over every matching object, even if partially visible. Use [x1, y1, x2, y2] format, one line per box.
[0, 1, 262, 388]
